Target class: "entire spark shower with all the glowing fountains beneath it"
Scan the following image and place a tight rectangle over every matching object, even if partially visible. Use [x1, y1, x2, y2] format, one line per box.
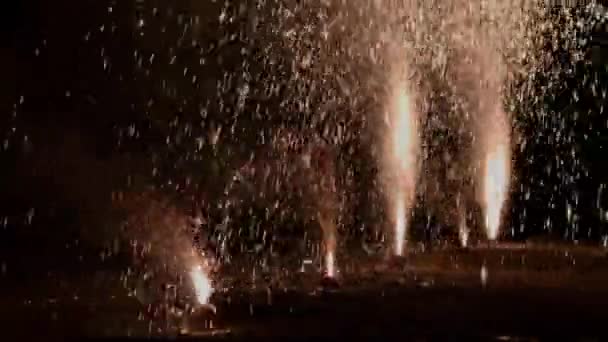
[0, 0, 608, 340]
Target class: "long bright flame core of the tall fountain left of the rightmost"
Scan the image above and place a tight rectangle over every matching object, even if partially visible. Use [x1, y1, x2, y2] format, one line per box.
[390, 85, 417, 256]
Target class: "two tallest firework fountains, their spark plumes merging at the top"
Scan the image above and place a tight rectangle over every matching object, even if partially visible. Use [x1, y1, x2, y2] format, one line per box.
[381, 1, 516, 252]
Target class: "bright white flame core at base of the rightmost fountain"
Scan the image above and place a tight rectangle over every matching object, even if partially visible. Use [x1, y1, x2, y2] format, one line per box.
[483, 123, 510, 240]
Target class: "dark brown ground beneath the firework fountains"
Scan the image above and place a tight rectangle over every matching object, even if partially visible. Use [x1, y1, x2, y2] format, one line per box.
[0, 245, 608, 340]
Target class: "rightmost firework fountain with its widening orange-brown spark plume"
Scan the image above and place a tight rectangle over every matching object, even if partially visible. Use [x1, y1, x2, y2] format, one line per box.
[432, 1, 538, 244]
